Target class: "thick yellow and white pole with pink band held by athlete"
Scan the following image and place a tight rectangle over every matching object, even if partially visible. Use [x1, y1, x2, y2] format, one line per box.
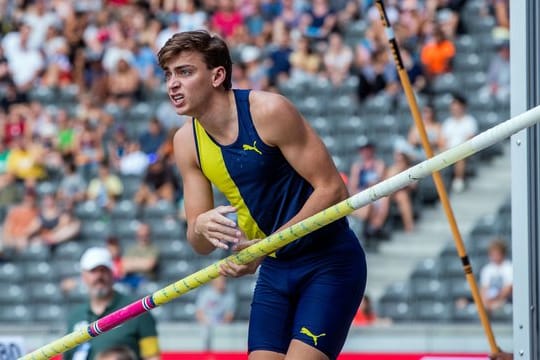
[21, 106, 540, 360]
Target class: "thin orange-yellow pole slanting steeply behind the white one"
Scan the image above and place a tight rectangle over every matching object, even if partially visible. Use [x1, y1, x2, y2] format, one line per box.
[375, 0, 499, 353]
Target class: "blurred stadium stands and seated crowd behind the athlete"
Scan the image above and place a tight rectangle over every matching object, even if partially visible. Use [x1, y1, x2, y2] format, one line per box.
[0, 0, 512, 358]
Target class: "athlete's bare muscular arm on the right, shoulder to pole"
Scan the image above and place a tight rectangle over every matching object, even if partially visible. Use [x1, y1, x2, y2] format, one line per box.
[250, 91, 348, 229]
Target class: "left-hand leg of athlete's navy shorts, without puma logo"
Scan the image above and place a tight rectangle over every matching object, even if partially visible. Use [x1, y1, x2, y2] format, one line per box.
[248, 262, 295, 359]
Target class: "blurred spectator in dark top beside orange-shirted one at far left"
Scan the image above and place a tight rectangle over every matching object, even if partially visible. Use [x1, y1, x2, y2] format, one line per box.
[31, 194, 81, 246]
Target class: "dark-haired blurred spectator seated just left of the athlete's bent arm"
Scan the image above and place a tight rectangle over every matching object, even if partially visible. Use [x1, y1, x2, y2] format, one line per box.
[134, 159, 176, 206]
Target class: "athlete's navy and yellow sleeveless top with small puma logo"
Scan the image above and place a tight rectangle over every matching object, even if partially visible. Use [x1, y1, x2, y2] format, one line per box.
[193, 90, 357, 258]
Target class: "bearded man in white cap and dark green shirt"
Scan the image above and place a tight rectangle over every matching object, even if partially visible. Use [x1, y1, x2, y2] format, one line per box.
[64, 247, 160, 360]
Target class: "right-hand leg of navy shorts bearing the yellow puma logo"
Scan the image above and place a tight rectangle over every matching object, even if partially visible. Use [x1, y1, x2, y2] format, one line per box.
[292, 253, 366, 359]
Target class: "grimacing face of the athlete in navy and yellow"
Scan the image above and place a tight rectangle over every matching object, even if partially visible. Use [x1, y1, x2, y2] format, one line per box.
[165, 52, 222, 116]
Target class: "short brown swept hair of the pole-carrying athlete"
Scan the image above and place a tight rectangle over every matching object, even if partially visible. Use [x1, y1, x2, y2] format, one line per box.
[158, 30, 232, 90]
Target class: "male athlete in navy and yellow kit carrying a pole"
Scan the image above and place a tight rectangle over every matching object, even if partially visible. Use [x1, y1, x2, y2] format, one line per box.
[158, 31, 366, 360]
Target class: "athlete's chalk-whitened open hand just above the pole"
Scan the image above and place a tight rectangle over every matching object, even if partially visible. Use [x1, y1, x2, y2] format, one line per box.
[194, 206, 242, 249]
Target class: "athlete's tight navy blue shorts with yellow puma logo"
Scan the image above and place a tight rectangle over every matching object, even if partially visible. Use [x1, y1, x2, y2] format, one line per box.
[248, 240, 367, 359]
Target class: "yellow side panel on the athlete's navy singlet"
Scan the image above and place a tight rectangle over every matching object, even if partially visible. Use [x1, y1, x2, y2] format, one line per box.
[193, 119, 267, 243]
